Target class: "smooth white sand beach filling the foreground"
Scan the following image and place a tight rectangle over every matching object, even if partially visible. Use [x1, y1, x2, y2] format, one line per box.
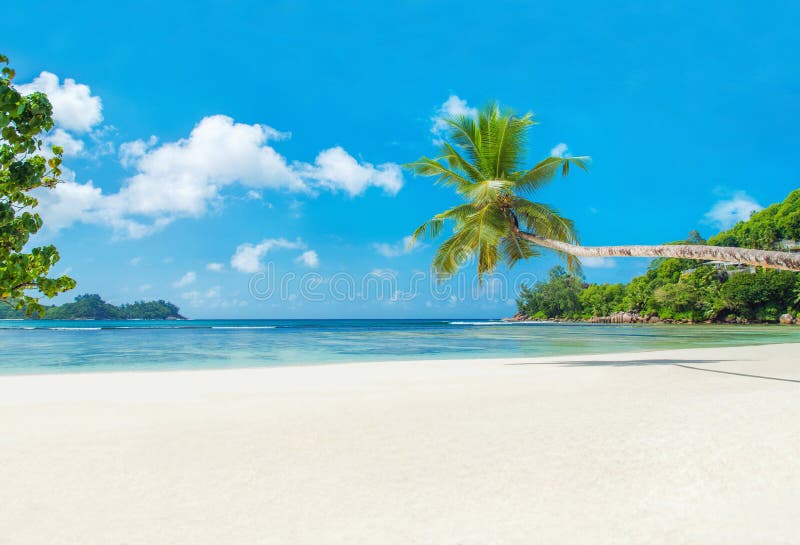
[0, 344, 800, 545]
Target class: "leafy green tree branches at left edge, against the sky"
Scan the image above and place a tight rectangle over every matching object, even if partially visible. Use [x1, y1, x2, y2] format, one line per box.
[0, 55, 75, 314]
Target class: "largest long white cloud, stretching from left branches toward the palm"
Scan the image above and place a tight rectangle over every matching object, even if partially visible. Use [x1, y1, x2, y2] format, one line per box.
[34, 115, 403, 238]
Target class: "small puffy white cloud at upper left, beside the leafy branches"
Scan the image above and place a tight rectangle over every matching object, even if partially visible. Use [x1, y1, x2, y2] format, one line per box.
[17, 72, 103, 132]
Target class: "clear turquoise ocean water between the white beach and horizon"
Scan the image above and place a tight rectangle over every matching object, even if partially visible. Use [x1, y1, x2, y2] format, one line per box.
[0, 320, 800, 374]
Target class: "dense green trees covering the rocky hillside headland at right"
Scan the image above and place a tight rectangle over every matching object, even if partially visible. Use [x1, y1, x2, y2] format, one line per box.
[517, 190, 800, 322]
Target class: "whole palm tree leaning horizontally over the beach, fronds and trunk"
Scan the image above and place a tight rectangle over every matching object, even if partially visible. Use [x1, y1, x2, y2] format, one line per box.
[406, 103, 800, 278]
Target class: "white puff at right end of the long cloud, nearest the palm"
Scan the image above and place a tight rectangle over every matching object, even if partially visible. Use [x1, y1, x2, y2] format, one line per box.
[304, 146, 403, 196]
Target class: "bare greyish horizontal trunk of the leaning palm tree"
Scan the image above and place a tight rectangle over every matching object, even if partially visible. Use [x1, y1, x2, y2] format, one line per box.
[517, 230, 800, 271]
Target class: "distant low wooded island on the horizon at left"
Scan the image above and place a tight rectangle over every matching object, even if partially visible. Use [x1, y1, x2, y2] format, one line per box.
[0, 293, 186, 320]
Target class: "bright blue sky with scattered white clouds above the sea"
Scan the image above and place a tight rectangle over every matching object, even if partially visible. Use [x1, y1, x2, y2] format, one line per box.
[2, 1, 800, 317]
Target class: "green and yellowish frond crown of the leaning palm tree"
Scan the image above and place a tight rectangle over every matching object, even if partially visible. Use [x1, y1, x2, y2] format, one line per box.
[407, 103, 589, 281]
